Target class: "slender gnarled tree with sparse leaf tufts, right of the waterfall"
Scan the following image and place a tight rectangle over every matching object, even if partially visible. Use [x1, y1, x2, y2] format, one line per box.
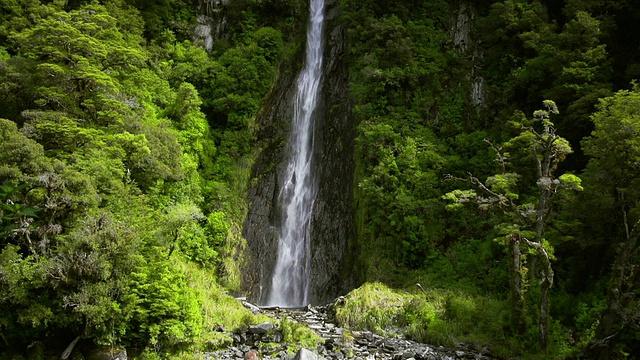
[444, 100, 582, 350]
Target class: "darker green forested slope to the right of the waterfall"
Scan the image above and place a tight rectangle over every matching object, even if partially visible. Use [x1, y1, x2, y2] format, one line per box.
[342, 0, 640, 358]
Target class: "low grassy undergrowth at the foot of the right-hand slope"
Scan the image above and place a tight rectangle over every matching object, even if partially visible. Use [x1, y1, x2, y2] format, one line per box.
[336, 283, 572, 359]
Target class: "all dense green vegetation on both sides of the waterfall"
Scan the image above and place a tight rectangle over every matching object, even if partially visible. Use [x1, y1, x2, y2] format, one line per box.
[0, 0, 640, 358]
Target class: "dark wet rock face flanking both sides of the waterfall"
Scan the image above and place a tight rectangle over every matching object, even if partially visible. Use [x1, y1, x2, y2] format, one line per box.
[243, 0, 355, 304]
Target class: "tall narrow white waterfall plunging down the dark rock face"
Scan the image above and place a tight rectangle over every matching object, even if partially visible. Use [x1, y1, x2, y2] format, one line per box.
[268, 0, 324, 306]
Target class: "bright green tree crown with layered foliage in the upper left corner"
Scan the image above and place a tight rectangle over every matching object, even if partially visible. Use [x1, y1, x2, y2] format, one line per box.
[10, 4, 144, 125]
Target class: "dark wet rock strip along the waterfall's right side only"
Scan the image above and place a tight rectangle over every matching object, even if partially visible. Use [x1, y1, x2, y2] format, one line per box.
[309, 0, 355, 304]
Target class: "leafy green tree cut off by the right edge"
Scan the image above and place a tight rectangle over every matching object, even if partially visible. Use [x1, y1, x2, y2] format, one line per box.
[583, 84, 640, 358]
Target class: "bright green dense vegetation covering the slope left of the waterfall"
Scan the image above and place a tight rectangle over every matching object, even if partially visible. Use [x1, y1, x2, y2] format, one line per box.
[0, 0, 308, 358]
